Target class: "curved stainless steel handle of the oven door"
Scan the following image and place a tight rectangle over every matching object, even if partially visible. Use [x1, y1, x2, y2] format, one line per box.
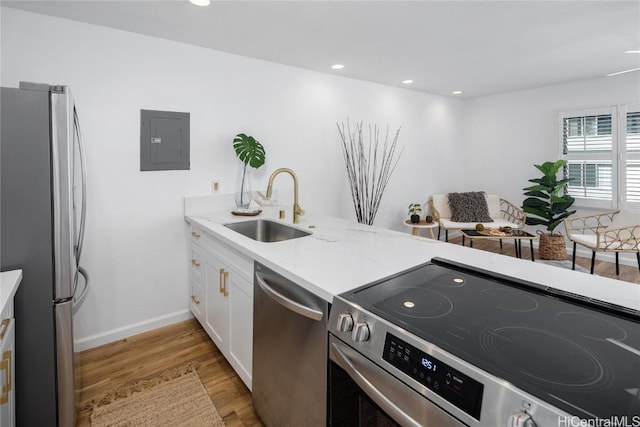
[331, 340, 422, 427]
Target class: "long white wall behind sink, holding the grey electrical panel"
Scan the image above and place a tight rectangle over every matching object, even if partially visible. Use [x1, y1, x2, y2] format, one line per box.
[0, 8, 463, 347]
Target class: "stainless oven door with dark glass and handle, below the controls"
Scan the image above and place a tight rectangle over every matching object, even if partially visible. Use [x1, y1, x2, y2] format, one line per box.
[329, 335, 465, 427]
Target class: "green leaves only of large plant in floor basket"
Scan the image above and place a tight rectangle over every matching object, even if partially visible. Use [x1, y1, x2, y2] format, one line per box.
[522, 160, 576, 235]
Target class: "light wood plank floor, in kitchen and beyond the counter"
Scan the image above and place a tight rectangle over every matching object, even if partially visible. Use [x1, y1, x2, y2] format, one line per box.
[77, 239, 640, 427]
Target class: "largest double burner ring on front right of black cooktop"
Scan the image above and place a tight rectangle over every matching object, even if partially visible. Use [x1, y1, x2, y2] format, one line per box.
[480, 326, 613, 391]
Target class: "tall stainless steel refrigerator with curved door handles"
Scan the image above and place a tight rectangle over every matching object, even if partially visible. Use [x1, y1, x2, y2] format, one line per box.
[0, 82, 88, 427]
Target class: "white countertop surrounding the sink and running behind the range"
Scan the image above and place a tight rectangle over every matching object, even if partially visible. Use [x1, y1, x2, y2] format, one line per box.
[186, 204, 640, 310]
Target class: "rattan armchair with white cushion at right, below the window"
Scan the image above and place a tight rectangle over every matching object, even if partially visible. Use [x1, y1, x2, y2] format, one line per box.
[563, 210, 640, 275]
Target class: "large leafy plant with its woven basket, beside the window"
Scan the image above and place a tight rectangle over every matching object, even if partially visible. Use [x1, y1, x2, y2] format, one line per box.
[522, 160, 576, 260]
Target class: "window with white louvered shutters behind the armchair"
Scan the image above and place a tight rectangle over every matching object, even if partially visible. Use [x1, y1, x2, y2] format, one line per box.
[560, 105, 640, 209]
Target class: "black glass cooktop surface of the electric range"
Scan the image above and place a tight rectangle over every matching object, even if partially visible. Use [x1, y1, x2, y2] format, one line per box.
[344, 259, 640, 418]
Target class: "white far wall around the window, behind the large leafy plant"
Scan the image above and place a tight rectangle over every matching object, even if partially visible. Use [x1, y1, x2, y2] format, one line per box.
[463, 73, 640, 204]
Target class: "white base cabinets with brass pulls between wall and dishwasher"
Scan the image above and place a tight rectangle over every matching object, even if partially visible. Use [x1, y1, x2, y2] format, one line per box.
[189, 224, 253, 390]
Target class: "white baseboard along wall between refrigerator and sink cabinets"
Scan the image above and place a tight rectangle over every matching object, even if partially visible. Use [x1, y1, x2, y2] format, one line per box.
[74, 309, 193, 352]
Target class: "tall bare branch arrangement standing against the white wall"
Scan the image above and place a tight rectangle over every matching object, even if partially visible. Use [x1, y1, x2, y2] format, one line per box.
[336, 120, 404, 225]
